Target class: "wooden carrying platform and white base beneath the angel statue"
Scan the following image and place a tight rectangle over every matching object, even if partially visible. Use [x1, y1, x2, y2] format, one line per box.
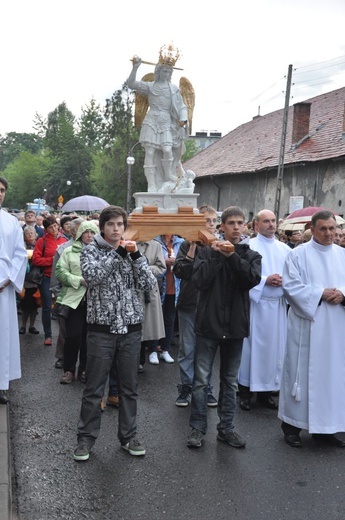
[125, 201, 215, 244]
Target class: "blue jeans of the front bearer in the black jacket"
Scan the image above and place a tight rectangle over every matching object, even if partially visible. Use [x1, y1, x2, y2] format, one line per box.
[189, 334, 243, 434]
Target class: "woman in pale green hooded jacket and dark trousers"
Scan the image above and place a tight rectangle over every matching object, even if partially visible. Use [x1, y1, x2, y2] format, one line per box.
[56, 221, 99, 385]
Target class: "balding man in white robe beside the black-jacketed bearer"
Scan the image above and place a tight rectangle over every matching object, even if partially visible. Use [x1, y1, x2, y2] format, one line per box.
[238, 209, 291, 410]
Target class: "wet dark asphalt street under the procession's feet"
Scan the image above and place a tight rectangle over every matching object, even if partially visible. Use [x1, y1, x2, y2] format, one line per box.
[0, 319, 345, 520]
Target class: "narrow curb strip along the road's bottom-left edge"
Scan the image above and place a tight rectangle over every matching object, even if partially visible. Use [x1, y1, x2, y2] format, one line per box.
[0, 404, 12, 520]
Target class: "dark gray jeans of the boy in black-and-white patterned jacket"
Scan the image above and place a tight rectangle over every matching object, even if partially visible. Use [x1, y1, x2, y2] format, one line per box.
[78, 330, 141, 447]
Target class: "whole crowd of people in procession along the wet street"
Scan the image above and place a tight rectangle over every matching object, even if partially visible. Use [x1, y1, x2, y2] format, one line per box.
[0, 174, 345, 461]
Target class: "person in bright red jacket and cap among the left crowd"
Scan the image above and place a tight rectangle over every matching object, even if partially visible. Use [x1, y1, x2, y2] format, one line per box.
[32, 215, 66, 346]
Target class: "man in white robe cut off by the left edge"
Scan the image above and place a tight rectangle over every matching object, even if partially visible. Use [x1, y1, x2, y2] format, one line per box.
[0, 177, 27, 404]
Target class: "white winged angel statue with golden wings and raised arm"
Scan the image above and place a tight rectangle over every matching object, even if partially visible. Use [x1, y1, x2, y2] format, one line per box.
[127, 52, 195, 193]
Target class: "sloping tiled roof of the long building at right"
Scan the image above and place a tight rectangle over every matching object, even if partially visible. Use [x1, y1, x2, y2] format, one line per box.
[184, 87, 345, 177]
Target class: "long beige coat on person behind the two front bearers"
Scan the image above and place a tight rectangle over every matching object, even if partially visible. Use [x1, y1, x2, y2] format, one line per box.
[138, 240, 166, 341]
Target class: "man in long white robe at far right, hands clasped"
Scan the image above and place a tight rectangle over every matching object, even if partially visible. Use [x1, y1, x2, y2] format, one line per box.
[278, 210, 345, 447]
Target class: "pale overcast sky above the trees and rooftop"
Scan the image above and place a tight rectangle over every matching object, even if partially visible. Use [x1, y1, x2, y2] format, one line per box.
[0, 0, 345, 135]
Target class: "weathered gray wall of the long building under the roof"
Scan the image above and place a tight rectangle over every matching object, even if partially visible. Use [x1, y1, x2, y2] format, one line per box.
[194, 158, 345, 219]
